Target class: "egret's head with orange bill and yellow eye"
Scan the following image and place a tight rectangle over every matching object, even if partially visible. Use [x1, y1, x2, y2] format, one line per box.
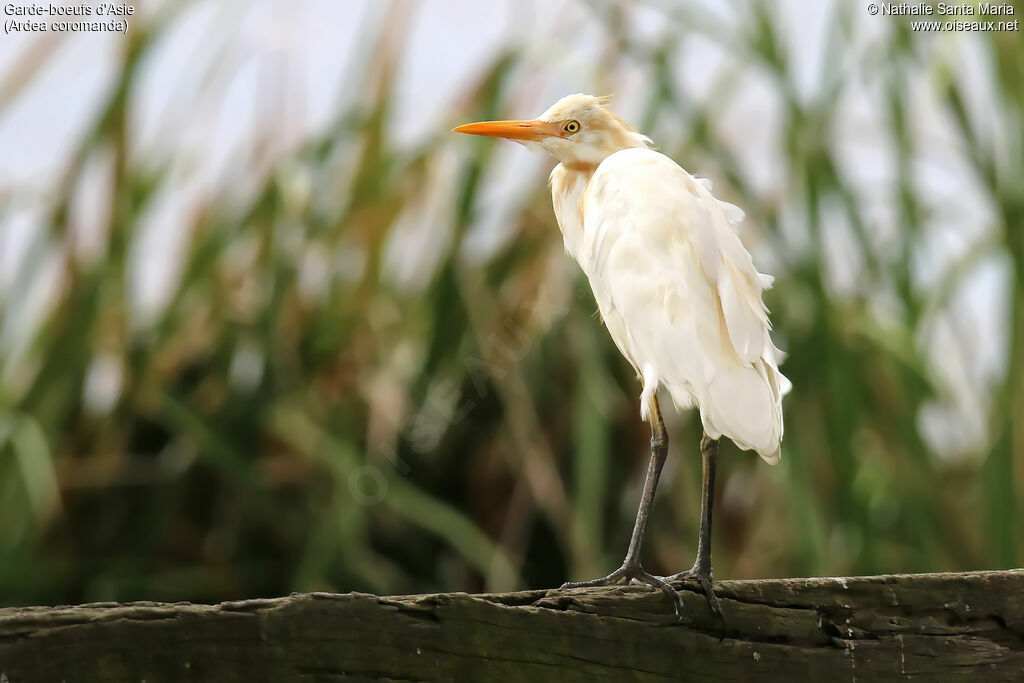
[453, 94, 650, 166]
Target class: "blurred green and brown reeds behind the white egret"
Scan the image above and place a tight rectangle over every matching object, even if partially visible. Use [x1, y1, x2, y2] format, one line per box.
[0, 2, 1024, 604]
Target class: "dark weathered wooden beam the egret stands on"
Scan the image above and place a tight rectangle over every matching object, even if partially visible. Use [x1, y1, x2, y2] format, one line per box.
[0, 569, 1024, 683]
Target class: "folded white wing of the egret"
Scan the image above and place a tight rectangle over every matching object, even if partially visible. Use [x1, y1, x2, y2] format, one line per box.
[579, 148, 788, 462]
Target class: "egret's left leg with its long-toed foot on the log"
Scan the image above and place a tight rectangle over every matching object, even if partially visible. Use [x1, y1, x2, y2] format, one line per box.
[562, 396, 683, 616]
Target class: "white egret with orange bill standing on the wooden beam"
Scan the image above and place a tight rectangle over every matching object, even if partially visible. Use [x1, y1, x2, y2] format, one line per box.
[453, 93, 792, 625]
